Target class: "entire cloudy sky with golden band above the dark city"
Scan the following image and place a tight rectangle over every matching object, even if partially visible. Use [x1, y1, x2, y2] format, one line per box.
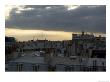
[5, 5, 106, 40]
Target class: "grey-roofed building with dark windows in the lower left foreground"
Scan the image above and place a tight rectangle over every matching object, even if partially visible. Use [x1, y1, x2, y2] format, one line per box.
[7, 53, 48, 71]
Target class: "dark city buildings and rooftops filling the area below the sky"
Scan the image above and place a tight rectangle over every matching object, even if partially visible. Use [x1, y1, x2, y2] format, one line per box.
[5, 31, 106, 72]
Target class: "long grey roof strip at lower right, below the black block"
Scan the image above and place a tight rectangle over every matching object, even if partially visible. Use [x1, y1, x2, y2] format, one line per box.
[51, 57, 106, 66]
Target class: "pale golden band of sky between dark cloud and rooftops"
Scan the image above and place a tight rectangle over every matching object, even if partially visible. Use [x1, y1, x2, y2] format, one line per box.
[5, 28, 72, 41]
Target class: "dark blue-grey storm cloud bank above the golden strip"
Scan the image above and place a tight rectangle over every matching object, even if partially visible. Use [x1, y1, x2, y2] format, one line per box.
[5, 5, 106, 33]
